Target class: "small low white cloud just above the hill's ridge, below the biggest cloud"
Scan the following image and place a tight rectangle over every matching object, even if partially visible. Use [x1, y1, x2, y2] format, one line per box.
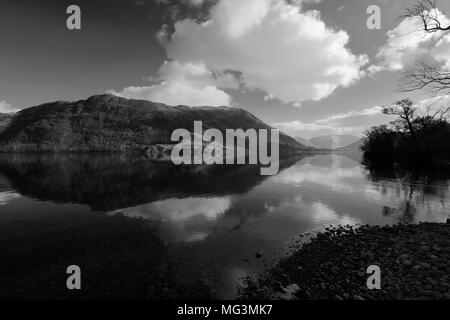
[108, 61, 235, 106]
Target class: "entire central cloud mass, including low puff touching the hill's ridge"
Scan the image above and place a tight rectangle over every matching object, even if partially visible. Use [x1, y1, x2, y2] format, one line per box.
[110, 0, 367, 105]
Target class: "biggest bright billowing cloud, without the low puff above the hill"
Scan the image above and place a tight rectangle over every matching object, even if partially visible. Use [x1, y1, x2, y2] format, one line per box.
[158, 0, 367, 102]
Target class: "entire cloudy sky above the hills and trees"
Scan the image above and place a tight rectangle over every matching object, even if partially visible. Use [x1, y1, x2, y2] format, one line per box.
[0, 0, 450, 138]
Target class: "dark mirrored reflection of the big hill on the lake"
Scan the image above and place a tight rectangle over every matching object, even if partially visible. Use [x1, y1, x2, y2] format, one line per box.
[0, 154, 299, 211]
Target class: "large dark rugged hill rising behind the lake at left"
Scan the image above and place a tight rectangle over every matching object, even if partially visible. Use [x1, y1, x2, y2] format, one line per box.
[0, 94, 305, 154]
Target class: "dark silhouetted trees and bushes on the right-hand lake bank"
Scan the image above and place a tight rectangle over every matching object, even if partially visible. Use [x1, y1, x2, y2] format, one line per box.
[361, 99, 450, 164]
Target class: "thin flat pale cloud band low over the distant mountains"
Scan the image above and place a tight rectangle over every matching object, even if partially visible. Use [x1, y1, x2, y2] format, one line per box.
[273, 106, 391, 138]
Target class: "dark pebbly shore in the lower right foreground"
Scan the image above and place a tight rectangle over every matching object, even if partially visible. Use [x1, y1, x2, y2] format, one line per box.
[240, 220, 450, 300]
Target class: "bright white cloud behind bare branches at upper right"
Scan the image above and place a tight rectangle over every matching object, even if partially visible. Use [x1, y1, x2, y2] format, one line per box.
[369, 9, 450, 74]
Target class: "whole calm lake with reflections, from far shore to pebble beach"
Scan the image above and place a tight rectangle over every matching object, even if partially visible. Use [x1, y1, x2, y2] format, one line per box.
[0, 152, 450, 299]
